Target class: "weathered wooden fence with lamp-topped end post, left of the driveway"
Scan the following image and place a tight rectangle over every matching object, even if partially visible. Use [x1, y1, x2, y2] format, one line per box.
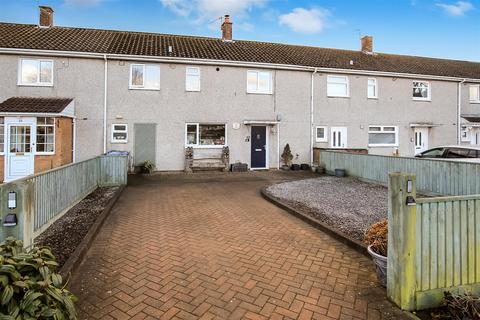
[0, 156, 128, 246]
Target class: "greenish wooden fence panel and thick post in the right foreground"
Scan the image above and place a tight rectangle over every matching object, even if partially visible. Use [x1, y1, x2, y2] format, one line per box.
[387, 173, 480, 310]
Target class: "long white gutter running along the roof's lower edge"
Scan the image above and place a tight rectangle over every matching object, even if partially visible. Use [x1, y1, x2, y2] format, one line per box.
[0, 48, 480, 83]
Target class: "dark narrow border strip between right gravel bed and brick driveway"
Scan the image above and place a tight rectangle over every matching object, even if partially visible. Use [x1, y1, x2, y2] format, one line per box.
[261, 186, 370, 257]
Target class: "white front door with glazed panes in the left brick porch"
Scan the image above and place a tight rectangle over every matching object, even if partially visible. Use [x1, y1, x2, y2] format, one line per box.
[5, 119, 35, 182]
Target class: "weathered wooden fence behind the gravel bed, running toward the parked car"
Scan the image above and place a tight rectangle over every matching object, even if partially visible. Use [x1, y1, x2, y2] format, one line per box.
[320, 150, 480, 195]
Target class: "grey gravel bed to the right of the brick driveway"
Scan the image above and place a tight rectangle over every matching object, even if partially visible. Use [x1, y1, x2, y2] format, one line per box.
[267, 176, 388, 241]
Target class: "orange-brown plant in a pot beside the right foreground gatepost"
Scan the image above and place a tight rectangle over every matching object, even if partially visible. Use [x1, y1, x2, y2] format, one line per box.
[364, 219, 388, 287]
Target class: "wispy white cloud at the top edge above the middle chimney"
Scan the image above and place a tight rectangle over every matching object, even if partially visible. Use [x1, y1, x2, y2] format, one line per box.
[160, 0, 267, 23]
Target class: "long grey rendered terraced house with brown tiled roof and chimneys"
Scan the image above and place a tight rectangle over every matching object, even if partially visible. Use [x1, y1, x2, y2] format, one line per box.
[0, 7, 480, 180]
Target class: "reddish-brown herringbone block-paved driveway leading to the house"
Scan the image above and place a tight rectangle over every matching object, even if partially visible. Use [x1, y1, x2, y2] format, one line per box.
[70, 172, 407, 319]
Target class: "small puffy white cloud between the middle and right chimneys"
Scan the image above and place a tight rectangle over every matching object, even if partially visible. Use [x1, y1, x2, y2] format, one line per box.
[279, 8, 331, 34]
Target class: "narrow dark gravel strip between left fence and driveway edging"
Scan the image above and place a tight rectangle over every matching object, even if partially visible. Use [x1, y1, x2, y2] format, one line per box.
[35, 187, 118, 269]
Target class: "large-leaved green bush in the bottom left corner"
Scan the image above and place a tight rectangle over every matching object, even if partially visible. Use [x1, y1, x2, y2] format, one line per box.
[0, 238, 77, 320]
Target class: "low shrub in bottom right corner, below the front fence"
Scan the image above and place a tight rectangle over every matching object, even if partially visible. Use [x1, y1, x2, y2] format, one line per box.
[443, 292, 480, 320]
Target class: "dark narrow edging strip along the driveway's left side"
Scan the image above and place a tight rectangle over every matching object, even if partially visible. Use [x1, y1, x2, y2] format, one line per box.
[59, 186, 126, 279]
